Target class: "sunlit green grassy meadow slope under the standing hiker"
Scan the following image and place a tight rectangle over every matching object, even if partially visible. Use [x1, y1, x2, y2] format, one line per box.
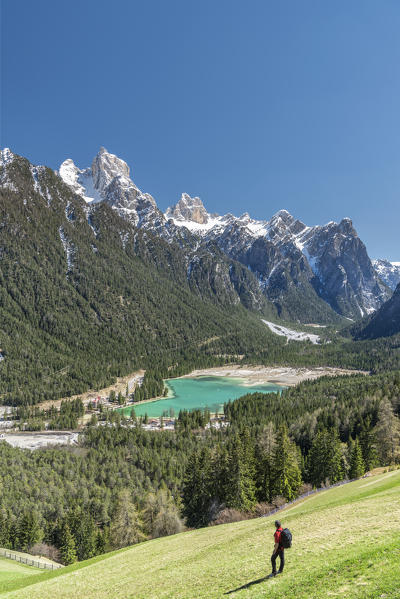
[2, 470, 400, 599]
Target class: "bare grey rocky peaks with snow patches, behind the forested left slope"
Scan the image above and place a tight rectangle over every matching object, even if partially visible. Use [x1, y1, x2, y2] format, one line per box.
[59, 148, 392, 323]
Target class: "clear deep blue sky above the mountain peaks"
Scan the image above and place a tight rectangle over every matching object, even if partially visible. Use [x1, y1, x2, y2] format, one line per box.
[0, 0, 400, 261]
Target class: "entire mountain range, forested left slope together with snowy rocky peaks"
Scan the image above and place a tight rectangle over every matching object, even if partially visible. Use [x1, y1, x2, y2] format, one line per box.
[0, 148, 398, 405]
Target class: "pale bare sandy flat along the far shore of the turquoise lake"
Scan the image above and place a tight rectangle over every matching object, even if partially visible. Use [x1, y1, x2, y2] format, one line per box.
[179, 364, 369, 387]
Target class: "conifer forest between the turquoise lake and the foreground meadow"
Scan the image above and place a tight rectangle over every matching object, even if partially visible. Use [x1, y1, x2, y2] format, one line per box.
[0, 373, 400, 562]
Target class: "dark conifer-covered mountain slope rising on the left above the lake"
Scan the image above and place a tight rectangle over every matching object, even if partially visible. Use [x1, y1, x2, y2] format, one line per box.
[0, 153, 280, 404]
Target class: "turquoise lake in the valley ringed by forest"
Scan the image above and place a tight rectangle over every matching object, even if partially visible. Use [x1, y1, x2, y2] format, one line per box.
[124, 376, 285, 418]
